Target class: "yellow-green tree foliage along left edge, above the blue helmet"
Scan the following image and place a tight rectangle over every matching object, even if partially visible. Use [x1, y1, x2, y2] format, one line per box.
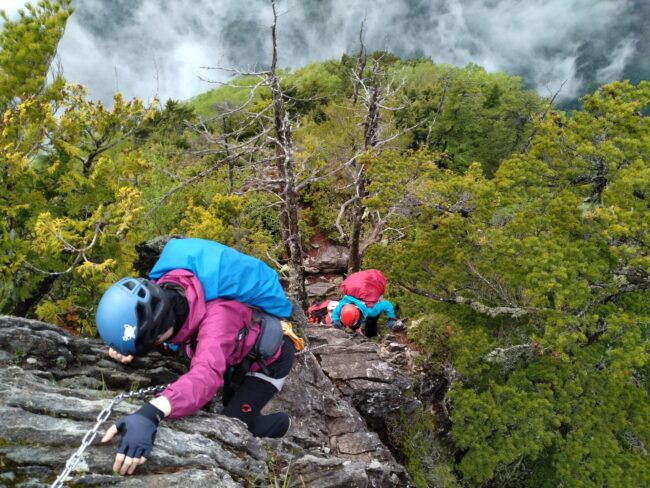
[0, 1, 151, 333]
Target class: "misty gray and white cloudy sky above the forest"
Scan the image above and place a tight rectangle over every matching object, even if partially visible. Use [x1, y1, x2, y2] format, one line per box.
[0, 0, 650, 105]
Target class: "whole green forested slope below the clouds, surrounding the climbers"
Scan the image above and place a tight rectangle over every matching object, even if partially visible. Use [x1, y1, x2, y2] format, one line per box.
[0, 0, 650, 487]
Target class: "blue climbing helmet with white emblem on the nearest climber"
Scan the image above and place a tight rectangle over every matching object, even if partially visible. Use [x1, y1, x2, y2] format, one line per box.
[96, 278, 171, 356]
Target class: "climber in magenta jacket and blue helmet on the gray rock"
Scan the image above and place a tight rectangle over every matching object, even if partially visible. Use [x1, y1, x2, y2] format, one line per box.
[97, 239, 295, 474]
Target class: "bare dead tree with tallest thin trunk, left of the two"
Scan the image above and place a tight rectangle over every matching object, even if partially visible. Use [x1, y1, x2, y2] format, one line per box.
[154, 0, 310, 309]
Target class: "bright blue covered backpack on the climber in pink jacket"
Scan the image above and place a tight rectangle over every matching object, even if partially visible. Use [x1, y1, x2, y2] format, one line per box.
[149, 239, 291, 317]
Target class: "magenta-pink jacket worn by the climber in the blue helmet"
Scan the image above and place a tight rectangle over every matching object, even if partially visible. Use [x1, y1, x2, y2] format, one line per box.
[157, 269, 282, 418]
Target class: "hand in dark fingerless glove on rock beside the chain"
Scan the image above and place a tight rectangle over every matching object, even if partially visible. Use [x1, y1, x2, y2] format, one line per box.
[102, 403, 164, 475]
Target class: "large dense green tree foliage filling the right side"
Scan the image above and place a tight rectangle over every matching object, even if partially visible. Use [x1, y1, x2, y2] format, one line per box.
[373, 82, 650, 487]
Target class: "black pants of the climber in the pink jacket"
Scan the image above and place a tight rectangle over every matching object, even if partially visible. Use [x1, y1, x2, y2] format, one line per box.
[223, 337, 296, 437]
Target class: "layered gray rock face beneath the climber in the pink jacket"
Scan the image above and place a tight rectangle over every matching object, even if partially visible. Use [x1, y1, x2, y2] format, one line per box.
[0, 316, 418, 488]
